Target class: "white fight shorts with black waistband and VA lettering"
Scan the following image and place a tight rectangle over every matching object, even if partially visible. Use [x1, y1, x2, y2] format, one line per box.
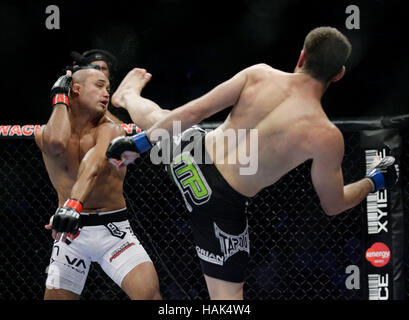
[46, 208, 152, 295]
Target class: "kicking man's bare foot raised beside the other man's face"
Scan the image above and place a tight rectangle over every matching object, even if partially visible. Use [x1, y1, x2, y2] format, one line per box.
[111, 68, 152, 108]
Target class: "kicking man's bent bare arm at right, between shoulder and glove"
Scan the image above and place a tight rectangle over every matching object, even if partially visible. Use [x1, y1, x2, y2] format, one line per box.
[311, 128, 372, 215]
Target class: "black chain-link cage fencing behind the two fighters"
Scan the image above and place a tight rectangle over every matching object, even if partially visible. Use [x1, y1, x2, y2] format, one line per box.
[0, 123, 409, 300]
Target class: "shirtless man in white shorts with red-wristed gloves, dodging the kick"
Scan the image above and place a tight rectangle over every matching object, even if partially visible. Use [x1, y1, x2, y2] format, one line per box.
[35, 67, 161, 300]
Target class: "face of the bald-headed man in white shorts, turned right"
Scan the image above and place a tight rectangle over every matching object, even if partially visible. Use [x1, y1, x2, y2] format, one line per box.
[79, 70, 110, 112]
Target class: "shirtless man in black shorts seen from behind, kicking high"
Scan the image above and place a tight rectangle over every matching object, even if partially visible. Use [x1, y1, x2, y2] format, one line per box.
[103, 27, 397, 299]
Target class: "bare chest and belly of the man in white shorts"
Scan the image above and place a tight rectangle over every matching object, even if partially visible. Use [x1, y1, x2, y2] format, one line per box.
[43, 116, 126, 212]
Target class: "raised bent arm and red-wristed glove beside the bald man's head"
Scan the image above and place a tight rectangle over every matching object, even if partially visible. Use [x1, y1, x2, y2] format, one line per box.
[35, 73, 72, 156]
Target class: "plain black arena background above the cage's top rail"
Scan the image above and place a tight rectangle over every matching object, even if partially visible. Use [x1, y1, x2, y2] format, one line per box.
[0, 0, 409, 124]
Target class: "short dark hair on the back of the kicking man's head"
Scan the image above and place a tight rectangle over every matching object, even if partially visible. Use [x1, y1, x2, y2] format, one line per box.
[303, 27, 352, 83]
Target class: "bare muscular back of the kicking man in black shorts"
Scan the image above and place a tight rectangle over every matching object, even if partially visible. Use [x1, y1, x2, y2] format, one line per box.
[206, 65, 337, 197]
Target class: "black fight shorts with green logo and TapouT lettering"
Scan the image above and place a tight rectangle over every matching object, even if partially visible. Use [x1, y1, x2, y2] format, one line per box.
[163, 127, 250, 283]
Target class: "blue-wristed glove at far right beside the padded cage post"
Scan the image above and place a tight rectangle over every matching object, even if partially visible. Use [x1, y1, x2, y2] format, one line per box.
[366, 156, 399, 193]
